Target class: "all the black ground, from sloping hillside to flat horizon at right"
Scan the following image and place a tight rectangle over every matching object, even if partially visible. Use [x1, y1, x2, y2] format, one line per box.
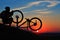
[0, 24, 60, 40]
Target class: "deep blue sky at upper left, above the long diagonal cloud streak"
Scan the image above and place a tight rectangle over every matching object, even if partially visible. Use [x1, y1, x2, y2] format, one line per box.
[0, 0, 35, 9]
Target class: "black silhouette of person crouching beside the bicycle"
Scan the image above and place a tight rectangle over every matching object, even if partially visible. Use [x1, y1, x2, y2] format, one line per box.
[0, 7, 13, 26]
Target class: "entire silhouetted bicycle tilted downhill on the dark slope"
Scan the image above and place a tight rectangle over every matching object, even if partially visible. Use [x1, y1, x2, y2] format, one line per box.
[13, 10, 42, 31]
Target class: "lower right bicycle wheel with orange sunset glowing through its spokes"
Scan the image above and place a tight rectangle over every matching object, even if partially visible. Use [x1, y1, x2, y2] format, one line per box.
[29, 17, 42, 31]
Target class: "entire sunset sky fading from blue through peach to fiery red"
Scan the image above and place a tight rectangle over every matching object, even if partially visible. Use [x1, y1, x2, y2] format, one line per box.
[0, 0, 60, 33]
